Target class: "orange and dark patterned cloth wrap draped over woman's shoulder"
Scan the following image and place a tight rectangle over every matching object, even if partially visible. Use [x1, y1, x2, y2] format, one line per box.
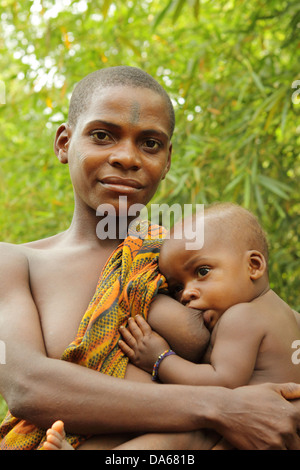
[0, 222, 167, 450]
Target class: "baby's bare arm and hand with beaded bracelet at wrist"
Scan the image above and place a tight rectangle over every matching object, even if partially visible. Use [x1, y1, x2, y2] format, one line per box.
[120, 304, 265, 388]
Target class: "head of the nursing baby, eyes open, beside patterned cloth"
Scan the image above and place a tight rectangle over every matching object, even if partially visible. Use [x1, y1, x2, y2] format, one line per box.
[159, 203, 268, 328]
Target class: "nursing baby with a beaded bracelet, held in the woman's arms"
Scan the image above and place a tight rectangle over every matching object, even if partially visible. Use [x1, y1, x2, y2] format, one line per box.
[44, 203, 300, 450]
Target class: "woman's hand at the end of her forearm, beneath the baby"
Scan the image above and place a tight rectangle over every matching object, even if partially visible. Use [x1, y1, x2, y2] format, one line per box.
[213, 383, 300, 450]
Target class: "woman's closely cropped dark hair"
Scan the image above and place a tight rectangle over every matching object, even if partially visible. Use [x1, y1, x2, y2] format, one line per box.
[68, 65, 175, 136]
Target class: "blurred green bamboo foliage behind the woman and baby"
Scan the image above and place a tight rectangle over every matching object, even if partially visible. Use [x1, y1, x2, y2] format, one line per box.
[0, 0, 300, 415]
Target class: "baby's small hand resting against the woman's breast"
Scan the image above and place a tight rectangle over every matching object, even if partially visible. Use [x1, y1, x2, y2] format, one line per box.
[119, 315, 169, 374]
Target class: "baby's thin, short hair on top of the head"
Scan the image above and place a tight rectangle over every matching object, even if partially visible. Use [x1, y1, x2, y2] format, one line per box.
[204, 202, 269, 263]
